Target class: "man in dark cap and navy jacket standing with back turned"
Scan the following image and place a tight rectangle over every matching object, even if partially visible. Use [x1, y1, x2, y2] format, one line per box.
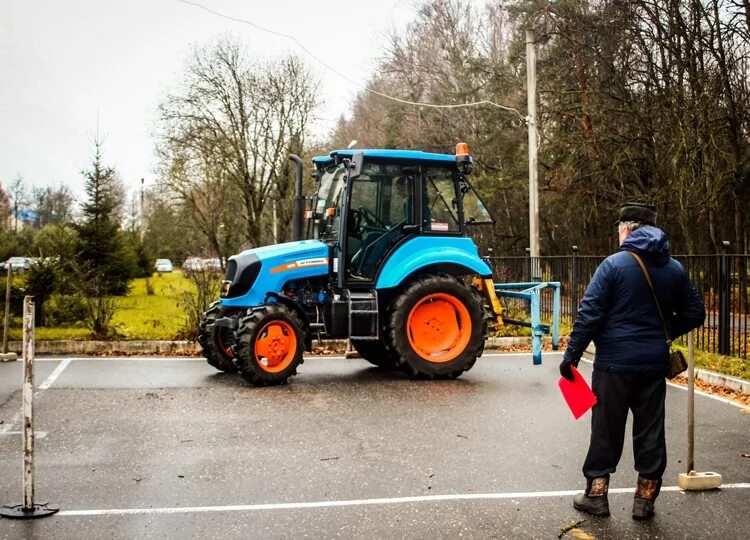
[560, 203, 705, 519]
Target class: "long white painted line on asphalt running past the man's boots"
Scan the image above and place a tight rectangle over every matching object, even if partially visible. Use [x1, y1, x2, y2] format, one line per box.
[57, 483, 750, 516]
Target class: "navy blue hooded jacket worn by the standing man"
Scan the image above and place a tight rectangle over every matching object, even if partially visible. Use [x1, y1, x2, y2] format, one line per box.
[565, 226, 706, 373]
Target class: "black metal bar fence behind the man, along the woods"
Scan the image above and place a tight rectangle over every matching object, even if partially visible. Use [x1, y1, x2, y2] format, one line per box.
[487, 247, 750, 359]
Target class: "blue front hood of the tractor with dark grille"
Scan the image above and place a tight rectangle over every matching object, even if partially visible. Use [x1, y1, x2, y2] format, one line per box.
[221, 240, 329, 307]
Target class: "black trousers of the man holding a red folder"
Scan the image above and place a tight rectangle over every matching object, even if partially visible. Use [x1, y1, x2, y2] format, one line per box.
[583, 371, 667, 480]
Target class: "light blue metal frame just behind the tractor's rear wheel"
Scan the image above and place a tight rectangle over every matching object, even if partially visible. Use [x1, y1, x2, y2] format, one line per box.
[495, 281, 560, 365]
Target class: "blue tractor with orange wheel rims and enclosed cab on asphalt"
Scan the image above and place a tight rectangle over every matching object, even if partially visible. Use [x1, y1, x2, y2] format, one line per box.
[199, 143, 502, 386]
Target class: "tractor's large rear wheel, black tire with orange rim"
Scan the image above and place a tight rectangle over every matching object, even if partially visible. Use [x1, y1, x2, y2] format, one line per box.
[388, 274, 487, 379]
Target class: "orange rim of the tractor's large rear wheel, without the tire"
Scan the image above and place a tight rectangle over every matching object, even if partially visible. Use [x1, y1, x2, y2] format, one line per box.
[406, 293, 471, 363]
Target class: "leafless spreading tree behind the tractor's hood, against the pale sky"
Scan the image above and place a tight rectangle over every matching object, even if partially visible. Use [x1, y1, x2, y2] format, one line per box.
[159, 38, 317, 250]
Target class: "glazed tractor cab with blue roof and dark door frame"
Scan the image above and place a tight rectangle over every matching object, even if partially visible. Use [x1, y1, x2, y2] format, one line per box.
[308, 143, 493, 289]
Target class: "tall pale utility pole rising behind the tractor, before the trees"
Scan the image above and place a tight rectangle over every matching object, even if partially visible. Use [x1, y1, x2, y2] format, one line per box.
[526, 28, 541, 280]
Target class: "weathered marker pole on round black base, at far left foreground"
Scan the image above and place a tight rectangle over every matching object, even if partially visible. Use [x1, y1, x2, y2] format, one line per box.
[0, 296, 60, 519]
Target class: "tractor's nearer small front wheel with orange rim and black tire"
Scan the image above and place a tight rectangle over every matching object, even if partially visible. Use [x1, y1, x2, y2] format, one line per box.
[235, 304, 305, 386]
